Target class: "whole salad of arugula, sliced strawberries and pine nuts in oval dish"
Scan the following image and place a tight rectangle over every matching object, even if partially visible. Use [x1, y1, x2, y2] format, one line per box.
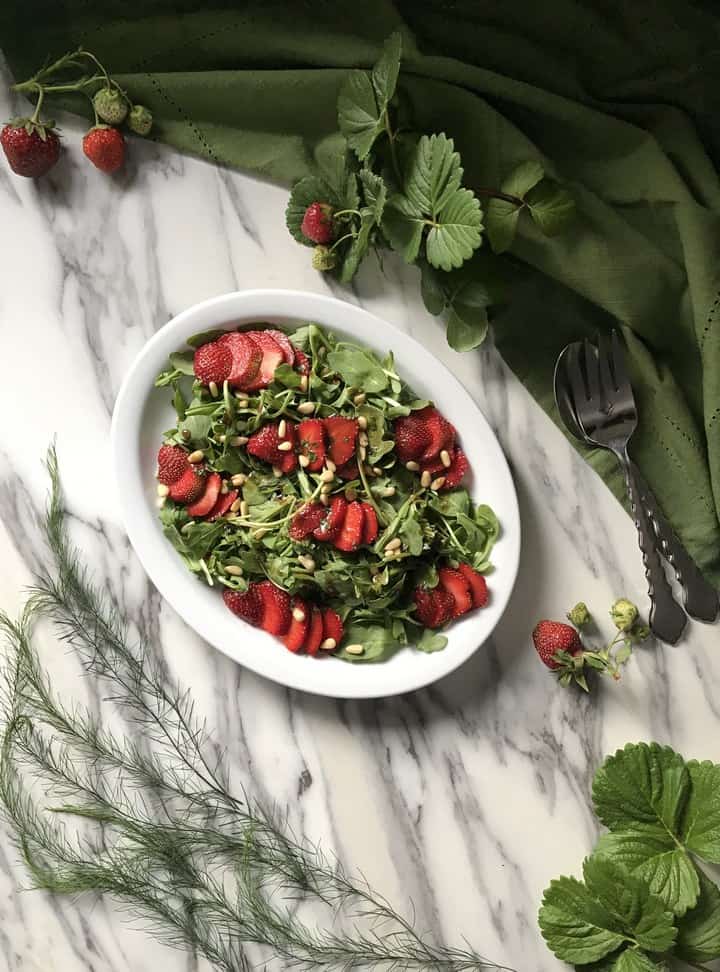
[156, 323, 499, 662]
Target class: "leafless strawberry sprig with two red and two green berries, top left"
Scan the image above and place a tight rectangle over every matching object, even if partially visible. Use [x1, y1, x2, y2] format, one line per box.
[0, 48, 153, 178]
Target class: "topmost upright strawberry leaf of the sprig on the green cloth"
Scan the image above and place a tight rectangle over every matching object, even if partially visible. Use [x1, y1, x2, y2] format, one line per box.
[338, 33, 402, 161]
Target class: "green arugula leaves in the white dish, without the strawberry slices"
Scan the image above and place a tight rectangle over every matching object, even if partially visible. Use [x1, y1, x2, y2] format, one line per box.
[156, 323, 499, 662]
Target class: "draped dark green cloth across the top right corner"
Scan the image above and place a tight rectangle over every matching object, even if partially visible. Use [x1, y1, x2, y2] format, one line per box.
[5, 0, 720, 584]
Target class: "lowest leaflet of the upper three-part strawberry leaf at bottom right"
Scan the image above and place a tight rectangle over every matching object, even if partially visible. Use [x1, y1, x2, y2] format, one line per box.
[595, 831, 700, 916]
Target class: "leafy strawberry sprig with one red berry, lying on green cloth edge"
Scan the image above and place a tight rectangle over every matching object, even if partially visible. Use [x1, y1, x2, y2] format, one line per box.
[286, 33, 574, 351]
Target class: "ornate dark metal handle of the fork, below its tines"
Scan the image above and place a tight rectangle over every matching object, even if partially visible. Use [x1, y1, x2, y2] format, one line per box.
[617, 450, 687, 645]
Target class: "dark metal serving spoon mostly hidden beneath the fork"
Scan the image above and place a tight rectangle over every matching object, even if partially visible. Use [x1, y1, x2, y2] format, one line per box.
[554, 341, 720, 622]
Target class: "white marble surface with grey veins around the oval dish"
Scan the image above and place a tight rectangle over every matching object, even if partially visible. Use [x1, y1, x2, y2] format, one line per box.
[0, 68, 720, 972]
